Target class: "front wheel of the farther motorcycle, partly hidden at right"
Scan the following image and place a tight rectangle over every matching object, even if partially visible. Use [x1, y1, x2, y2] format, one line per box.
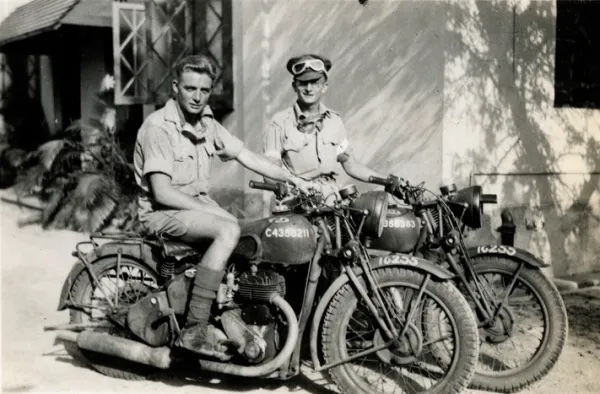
[471, 256, 567, 392]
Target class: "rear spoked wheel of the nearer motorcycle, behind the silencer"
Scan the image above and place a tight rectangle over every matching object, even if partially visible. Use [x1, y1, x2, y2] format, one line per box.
[66, 257, 158, 380]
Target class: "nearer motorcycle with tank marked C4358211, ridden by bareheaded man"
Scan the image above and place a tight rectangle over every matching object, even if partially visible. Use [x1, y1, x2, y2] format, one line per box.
[49, 182, 478, 393]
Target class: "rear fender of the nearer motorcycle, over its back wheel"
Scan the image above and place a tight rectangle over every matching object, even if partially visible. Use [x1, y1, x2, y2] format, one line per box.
[58, 242, 158, 311]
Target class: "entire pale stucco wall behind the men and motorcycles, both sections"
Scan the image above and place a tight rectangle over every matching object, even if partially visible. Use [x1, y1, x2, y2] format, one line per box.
[207, 0, 600, 275]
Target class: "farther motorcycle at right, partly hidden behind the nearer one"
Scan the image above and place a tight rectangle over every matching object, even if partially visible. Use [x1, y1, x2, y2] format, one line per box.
[352, 176, 568, 393]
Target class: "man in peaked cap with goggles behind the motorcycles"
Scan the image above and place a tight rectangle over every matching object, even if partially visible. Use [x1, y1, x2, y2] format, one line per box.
[263, 54, 386, 202]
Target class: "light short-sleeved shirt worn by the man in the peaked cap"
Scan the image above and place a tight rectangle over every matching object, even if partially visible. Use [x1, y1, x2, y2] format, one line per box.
[263, 103, 350, 180]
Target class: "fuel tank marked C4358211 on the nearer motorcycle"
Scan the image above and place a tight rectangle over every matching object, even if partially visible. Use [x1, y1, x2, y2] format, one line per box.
[234, 214, 317, 264]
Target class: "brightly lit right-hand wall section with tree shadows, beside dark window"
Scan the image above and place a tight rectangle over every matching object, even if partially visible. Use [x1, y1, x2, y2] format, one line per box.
[443, 0, 600, 275]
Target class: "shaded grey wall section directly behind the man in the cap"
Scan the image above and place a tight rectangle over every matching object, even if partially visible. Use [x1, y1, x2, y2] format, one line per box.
[215, 0, 445, 216]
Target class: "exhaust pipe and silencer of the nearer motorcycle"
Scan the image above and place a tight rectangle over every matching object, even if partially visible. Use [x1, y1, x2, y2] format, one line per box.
[57, 294, 298, 377]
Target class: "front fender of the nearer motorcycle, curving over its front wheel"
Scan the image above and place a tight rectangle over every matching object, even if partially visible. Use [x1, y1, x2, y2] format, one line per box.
[310, 253, 455, 368]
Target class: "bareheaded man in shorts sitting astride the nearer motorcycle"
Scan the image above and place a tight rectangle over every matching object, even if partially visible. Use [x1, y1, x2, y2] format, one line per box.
[134, 55, 308, 359]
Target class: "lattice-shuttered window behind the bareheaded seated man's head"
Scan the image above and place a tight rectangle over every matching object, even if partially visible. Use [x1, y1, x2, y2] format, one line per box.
[113, 0, 233, 110]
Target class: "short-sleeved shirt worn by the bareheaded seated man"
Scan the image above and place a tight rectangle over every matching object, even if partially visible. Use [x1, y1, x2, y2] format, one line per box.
[133, 99, 244, 218]
